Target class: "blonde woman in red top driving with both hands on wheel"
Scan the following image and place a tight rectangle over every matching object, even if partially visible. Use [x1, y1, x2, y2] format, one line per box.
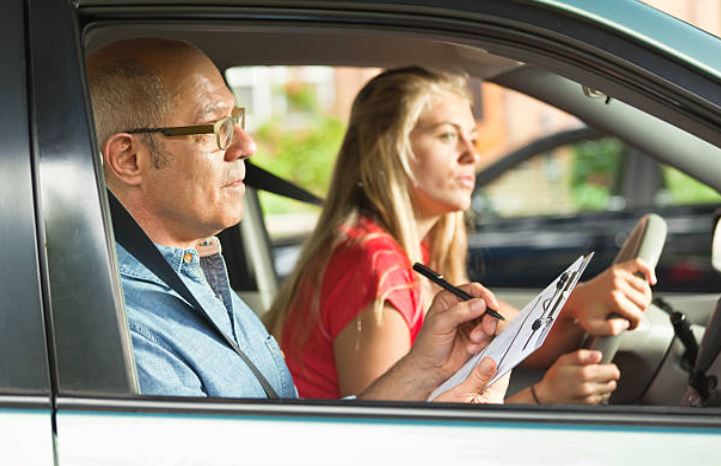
[266, 67, 655, 403]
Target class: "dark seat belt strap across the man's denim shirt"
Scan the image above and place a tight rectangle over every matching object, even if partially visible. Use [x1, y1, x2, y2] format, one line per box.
[108, 191, 278, 399]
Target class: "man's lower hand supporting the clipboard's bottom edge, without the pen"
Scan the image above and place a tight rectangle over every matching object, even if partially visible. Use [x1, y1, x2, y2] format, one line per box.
[433, 357, 511, 404]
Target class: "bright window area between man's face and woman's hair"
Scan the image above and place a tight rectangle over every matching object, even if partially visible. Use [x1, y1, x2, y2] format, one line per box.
[226, 66, 379, 246]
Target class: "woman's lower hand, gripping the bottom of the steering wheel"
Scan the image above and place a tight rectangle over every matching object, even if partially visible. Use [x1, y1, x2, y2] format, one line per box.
[532, 350, 621, 404]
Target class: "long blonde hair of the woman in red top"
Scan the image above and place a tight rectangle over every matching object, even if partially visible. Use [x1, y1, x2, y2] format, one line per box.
[265, 66, 470, 351]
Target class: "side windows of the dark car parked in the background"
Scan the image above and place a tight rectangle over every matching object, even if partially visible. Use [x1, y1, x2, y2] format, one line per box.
[474, 137, 721, 224]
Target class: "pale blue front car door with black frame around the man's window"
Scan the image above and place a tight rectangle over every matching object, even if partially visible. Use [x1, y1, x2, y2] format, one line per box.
[29, 1, 721, 465]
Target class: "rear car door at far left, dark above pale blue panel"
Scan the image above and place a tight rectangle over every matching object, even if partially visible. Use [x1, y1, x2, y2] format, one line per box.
[0, 2, 54, 466]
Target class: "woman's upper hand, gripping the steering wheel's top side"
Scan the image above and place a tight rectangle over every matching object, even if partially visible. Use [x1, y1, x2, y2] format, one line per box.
[564, 259, 656, 335]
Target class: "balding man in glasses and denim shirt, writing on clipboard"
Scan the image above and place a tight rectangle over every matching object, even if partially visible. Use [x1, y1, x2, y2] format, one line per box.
[88, 39, 505, 402]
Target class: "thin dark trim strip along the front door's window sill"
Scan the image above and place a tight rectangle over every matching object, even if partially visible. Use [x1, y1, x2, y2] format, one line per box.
[57, 398, 721, 433]
